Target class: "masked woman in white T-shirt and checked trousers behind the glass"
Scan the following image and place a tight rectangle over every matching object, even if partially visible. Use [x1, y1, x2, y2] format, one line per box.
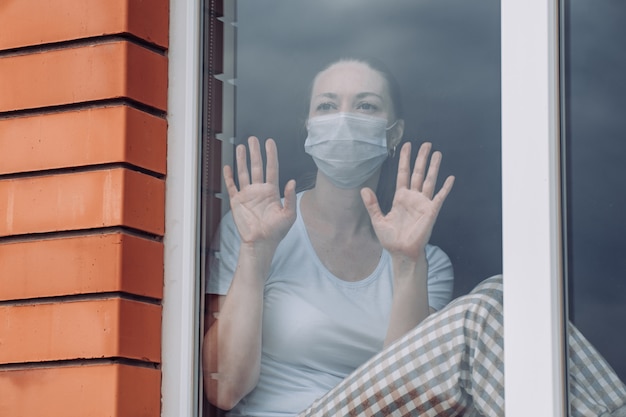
[203, 60, 623, 416]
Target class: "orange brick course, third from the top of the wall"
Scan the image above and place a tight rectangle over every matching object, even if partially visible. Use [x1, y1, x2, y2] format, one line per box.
[0, 106, 167, 174]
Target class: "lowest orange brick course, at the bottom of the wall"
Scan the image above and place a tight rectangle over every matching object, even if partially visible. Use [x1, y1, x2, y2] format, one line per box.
[0, 364, 161, 417]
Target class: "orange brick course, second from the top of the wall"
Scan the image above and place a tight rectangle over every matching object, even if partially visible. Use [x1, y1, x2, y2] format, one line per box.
[0, 41, 167, 112]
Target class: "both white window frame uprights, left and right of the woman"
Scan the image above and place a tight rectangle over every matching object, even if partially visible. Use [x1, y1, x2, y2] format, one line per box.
[161, 0, 567, 417]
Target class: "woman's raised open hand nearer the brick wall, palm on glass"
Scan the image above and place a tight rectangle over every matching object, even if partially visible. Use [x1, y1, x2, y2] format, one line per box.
[224, 136, 296, 252]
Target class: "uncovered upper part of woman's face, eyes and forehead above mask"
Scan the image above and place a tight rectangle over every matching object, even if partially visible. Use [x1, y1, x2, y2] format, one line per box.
[309, 61, 393, 124]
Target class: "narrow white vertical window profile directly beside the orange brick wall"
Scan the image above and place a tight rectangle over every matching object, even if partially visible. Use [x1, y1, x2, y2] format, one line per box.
[161, 0, 202, 417]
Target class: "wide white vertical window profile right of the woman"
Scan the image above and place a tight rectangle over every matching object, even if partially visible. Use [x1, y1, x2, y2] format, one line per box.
[501, 0, 567, 417]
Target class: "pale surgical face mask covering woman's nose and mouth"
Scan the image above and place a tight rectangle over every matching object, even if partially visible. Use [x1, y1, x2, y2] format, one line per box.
[304, 113, 388, 188]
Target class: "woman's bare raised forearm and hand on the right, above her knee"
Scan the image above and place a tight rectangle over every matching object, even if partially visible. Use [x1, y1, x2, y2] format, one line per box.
[361, 143, 454, 345]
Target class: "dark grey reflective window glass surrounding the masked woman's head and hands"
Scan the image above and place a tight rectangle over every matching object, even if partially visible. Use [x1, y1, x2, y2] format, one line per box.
[201, 0, 502, 412]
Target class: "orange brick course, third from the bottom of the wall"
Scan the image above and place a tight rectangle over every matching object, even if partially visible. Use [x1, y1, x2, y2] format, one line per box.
[0, 233, 163, 301]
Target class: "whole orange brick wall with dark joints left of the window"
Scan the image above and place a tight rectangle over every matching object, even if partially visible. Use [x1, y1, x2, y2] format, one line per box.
[0, 0, 169, 417]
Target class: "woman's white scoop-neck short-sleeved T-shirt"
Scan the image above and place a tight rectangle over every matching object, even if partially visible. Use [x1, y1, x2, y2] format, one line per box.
[207, 193, 453, 417]
